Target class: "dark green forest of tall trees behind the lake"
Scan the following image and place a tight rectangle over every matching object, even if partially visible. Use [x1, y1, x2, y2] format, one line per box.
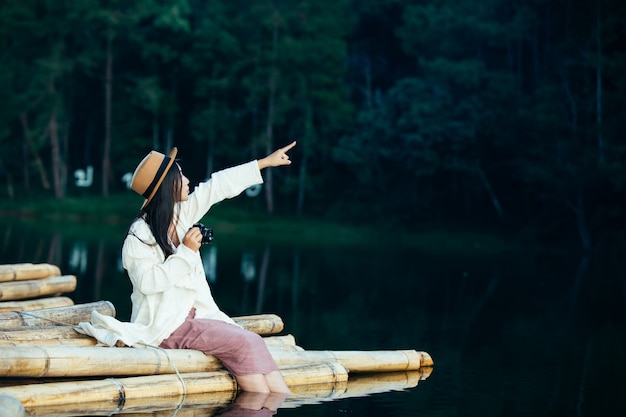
[0, 0, 626, 250]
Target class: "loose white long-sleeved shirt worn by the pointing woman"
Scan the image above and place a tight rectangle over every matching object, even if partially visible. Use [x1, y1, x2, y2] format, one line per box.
[77, 161, 263, 346]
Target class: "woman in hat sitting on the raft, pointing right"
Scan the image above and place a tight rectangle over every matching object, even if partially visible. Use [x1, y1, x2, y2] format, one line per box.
[79, 142, 296, 393]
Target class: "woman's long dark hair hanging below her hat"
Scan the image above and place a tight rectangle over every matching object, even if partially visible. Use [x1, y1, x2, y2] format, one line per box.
[126, 163, 182, 259]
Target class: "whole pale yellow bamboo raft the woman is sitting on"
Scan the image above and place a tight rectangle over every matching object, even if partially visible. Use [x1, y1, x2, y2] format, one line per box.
[0, 264, 434, 417]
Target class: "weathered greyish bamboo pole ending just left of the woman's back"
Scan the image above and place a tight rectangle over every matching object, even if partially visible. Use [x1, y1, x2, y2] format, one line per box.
[0, 301, 115, 328]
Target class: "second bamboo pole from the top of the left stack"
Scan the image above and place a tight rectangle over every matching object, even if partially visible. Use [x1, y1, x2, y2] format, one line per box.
[0, 275, 76, 301]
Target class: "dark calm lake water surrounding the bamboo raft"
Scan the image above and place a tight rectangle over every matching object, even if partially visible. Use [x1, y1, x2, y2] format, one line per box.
[0, 219, 626, 417]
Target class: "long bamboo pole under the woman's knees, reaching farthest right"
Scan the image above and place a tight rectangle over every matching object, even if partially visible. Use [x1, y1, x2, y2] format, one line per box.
[0, 345, 432, 377]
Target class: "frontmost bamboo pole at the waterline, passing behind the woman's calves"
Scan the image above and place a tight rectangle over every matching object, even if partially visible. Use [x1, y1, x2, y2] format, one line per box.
[0, 363, 348, 408]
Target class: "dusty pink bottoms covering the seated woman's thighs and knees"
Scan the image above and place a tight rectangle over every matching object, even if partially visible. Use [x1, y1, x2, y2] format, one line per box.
[160, 308, 278, 375]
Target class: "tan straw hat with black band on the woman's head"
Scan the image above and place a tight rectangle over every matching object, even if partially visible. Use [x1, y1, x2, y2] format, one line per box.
[130, 147, 178, 208]
